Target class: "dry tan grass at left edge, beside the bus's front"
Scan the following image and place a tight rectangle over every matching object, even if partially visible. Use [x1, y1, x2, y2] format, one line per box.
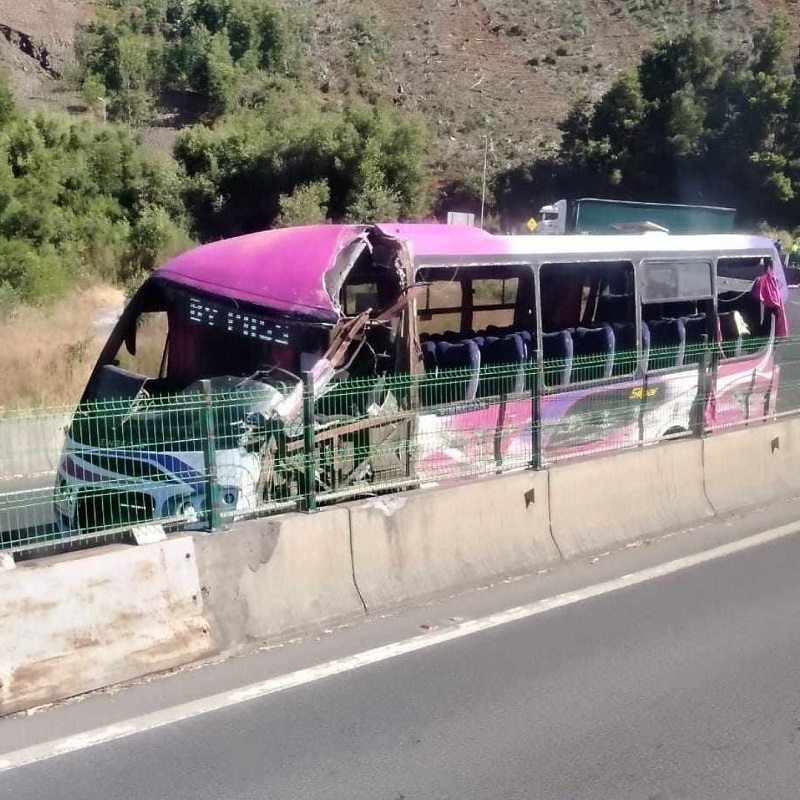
[0, 286, 123, 409]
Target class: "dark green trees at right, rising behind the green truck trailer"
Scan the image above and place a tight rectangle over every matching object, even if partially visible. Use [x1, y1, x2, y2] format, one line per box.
[498, 12, 800, 225]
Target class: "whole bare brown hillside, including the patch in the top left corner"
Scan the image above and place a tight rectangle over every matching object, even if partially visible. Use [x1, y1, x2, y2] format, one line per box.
[0, 0, 800, 172]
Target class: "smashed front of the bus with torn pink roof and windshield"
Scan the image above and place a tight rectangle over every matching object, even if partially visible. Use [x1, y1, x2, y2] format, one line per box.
[56, 226, 413, 532]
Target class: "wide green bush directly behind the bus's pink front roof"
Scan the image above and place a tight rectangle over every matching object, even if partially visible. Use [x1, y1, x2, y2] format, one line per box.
[175, 92, 430, 240]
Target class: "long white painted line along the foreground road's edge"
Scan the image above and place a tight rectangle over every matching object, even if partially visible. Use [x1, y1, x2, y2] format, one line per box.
[0, 523, 800, 772]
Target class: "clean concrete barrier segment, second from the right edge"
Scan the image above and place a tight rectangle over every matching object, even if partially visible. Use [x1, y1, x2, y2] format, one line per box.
[550, 439, 714, 560]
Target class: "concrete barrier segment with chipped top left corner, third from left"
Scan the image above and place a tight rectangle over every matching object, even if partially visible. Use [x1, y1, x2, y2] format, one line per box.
[349, 472, 560, 611]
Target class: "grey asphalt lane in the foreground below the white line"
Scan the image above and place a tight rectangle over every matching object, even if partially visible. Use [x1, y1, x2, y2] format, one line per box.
[0, 512, 800, 800]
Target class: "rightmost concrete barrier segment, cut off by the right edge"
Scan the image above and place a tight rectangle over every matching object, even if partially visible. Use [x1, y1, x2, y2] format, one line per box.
[703, 419, 800, 514]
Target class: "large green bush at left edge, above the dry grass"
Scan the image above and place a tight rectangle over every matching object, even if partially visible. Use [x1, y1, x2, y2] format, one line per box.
[0, 75, 194, 308]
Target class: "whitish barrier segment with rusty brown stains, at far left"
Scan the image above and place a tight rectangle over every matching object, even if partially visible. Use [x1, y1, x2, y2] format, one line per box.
[0, 536, 214, 714]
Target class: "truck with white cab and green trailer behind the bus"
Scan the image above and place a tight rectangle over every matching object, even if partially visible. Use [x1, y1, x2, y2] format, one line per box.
[535, 197, 736, 234]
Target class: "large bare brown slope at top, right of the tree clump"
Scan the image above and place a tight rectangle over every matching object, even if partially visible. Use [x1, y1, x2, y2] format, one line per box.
[317, 0, 800, 177]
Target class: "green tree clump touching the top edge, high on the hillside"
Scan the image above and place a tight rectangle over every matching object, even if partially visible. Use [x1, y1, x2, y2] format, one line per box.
[76, 0, 306, 123]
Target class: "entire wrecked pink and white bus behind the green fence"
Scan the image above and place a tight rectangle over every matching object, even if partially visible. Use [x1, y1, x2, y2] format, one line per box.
[56, 224, 787, 531]
